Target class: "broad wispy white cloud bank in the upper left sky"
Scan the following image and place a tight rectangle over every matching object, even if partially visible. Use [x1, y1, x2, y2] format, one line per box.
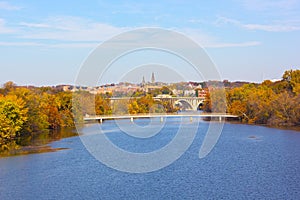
[0, 16, 129, 48]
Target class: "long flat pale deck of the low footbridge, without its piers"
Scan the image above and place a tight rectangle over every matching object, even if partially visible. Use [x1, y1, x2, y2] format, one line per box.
[83, 113, 238, 121]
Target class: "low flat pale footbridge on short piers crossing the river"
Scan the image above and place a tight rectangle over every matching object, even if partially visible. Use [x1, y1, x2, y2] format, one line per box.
[83, 113, 239, 123]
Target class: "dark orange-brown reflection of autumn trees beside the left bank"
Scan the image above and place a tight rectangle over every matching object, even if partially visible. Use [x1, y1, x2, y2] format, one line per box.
[0, 129, 77, 157]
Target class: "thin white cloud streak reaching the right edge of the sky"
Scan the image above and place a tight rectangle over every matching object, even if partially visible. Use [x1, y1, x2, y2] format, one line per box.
[215, 17, 300, 32]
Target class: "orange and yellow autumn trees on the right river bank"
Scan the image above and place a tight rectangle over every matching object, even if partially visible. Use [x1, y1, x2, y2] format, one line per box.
[204, 70, 300, 126]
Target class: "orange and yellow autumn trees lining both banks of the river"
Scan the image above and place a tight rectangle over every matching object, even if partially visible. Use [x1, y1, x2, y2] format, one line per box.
[0, 70, 300, 157]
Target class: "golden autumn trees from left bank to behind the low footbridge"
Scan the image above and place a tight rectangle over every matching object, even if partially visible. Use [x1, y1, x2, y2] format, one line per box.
[0, 82, 176, 151]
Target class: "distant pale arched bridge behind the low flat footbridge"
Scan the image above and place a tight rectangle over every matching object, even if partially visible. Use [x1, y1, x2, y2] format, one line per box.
[110, 95, 205, 110]
